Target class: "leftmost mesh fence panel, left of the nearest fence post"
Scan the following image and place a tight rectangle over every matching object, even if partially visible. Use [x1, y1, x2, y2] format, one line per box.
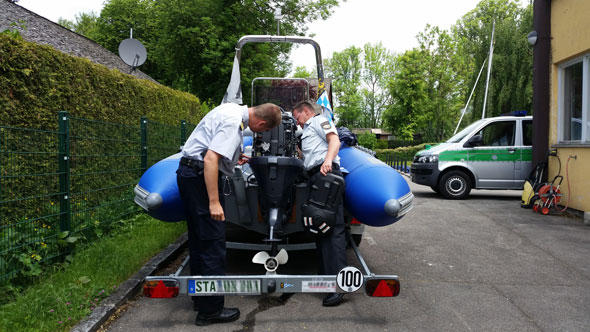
[0, 127, 63, 280]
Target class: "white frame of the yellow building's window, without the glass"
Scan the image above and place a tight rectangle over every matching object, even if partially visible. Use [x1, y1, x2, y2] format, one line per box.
[557, 53, 590, 145]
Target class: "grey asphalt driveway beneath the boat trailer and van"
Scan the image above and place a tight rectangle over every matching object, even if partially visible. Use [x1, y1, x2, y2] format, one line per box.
[108, 184, 590, 331]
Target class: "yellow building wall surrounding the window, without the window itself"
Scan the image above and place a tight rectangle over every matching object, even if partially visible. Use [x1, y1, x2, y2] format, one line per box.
[549, 0, 590, 213]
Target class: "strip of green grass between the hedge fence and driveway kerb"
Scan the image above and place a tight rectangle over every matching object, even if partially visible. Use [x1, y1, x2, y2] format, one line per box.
[0, 214, 186, 331]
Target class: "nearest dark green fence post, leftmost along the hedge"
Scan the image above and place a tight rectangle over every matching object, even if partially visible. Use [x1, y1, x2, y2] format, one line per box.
[58, 111, 72, 232]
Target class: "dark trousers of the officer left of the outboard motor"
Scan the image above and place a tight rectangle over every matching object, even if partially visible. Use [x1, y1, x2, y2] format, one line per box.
[176, 165, 225, 314]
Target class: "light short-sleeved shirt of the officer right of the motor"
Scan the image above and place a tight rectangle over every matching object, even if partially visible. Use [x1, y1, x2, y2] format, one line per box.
[301, 115, 340, 170]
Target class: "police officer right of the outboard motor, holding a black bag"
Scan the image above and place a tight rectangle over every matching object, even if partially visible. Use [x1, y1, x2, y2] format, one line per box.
[293, 101, 346, 306]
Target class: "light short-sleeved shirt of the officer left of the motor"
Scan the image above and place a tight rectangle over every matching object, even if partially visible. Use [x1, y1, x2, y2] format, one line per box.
[182, 103, 248, 175]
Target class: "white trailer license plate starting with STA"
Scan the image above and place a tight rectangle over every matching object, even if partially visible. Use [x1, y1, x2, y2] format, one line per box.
[188, 279, 261, 295]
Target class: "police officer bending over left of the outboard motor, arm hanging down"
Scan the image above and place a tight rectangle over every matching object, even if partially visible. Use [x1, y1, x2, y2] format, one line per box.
[176, 103, 281, 326]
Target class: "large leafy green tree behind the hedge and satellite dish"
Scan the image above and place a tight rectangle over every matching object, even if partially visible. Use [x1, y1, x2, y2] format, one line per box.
[89, 0, 338, 103]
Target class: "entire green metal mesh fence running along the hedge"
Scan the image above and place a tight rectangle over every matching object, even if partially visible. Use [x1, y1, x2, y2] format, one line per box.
[0, 112, 195, 281]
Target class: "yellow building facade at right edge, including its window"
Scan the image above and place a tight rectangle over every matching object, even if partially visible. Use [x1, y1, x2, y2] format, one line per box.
[548, 0, 590, 220]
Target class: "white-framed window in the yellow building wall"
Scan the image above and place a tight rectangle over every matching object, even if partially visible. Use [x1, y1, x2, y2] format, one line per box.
[558, 55, 590, 143]
